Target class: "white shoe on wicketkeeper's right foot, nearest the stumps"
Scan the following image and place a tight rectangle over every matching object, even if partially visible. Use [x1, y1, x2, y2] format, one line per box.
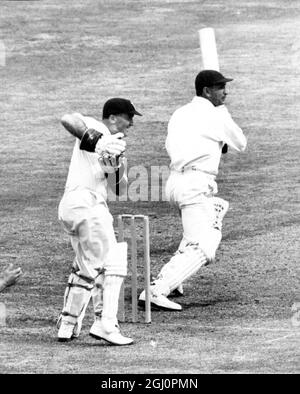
[90, 319, 133, 346]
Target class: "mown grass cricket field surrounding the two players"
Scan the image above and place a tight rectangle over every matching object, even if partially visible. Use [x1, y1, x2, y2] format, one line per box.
[0, 0, 300, 374]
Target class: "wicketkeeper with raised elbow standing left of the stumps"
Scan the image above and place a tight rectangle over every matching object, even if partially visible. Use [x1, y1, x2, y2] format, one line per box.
[58, 98, 141, 345]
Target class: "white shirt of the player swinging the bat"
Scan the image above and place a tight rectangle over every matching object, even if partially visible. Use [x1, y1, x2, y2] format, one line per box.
[166, 96, 247, 176]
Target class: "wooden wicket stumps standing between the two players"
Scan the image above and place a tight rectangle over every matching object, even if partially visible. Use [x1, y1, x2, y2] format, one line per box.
[118, 215, 151, 323]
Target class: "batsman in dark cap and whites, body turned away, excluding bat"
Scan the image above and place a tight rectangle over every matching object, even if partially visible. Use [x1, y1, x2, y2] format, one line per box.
[139, 70, 247, 311]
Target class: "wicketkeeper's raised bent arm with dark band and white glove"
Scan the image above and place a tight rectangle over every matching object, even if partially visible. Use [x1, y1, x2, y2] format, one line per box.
[61, 113, 126, 155]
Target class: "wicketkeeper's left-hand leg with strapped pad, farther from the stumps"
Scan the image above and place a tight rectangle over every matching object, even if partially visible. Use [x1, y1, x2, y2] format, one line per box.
[58, 195, 109, 341]
